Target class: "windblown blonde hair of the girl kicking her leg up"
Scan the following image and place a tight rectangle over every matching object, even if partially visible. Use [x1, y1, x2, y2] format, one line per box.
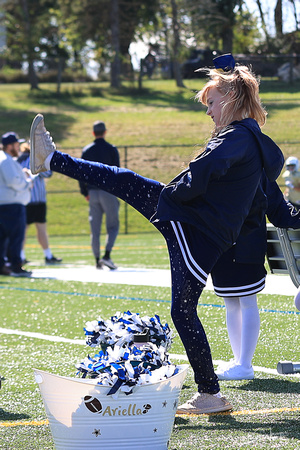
[195, 65, 267, 132]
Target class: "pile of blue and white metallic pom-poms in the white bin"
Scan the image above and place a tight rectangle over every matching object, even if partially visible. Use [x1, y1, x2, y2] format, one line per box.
[76, 311, 177, 395]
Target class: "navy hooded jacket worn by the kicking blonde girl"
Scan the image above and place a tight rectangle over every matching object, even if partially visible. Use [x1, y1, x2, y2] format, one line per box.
[152, 119, 284, 251]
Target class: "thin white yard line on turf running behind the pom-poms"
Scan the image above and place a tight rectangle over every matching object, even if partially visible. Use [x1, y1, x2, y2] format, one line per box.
[0, 327, 300, 378]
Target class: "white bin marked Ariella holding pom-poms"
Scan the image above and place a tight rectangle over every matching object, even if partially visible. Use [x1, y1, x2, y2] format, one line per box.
[34, 364, 188, 450]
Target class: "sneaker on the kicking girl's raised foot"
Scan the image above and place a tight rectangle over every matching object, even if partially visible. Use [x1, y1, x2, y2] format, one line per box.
[30, 114, 56, 174]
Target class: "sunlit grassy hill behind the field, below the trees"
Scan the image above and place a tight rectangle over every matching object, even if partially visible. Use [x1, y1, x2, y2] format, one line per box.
[0, 79, 300, 235]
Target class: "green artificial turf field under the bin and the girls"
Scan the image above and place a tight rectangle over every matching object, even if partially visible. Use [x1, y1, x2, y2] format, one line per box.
[0, 232, 300, 450]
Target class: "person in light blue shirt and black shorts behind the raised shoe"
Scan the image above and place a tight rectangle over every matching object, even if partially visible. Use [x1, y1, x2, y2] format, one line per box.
[18, 142, 62, 264]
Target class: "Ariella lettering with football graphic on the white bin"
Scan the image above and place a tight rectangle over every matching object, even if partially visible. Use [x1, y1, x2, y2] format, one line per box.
[84, 395, 152, 417]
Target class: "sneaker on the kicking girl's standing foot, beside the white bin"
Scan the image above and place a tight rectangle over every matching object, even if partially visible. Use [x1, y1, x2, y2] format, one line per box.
[177, 392, 233, 414]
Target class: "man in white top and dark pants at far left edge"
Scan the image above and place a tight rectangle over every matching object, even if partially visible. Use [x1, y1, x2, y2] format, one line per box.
[0, 131, 32, 277]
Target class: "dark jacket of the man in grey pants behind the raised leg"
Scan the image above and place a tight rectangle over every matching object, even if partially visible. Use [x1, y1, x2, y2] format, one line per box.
[79, 138, 120, 197]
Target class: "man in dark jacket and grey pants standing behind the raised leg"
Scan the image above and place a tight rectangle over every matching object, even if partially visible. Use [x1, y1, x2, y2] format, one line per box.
[79, 121, 120, 270]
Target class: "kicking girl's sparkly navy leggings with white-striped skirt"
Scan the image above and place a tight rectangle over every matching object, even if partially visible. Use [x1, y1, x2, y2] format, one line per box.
[50, 152, 220, 394]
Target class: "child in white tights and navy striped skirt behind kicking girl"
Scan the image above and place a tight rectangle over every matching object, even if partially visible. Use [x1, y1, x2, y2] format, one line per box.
[211, 177, 300, 380]
